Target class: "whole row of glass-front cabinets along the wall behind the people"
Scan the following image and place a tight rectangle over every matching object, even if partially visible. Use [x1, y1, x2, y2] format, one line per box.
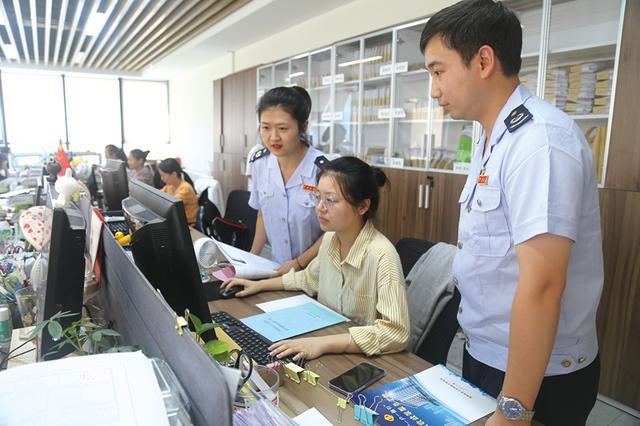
[258, 0, 625, 183]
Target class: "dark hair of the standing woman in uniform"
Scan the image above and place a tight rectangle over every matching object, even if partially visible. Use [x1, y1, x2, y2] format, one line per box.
[258, 86, 311, 146]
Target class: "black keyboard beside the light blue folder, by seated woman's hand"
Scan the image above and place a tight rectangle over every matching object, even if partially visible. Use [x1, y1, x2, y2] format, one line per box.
[211, 312, 291, 365]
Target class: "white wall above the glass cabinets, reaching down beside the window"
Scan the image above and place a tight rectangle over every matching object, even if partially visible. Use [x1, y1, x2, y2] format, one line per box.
[170, 0, 454, 173]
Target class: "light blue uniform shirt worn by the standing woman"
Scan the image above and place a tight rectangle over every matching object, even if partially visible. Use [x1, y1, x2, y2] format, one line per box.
[249, 147, 323, 264]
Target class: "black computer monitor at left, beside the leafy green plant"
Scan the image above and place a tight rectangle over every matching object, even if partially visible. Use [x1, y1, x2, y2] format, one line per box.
[37, 185, 86, 360]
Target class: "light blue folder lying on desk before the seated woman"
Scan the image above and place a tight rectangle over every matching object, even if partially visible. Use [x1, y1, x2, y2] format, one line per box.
[241, 302, 347, 342]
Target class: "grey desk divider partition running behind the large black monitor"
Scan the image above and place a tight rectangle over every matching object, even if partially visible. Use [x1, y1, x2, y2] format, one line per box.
[80, 196, 232, 425]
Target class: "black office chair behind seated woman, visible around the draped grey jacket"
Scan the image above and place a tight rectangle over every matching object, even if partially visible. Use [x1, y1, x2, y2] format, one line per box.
[396, 238, 460, 365]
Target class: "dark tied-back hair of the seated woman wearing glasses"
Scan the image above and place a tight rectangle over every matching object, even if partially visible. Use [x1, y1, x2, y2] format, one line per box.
[318, 157, 388, 222]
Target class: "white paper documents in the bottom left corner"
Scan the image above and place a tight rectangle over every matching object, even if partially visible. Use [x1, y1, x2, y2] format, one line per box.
[0, 352, 169, 426]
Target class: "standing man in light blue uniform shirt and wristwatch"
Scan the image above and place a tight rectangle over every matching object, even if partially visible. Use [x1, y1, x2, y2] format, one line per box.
[420, 0, 603, 425]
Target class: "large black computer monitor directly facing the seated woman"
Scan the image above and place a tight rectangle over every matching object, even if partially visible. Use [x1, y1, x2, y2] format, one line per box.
[122, 181, 216, 340]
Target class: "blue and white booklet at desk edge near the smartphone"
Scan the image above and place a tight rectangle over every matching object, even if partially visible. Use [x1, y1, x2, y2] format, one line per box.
[353, 365, 496, 426]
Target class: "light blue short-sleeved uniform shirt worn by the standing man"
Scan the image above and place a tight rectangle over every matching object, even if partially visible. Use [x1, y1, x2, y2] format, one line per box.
[453, 85, 604, 376]
